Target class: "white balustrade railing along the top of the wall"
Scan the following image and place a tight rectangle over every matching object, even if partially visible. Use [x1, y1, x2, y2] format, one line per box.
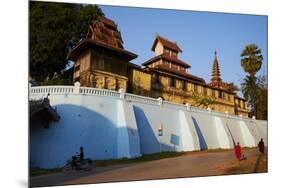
[29, 82, 258, 121]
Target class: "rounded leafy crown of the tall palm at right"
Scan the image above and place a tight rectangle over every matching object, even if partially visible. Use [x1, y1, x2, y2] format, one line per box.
[238, 44, 263, 77]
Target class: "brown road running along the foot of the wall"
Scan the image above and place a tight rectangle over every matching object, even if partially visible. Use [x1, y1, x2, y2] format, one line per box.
[30, 149, 258, 186]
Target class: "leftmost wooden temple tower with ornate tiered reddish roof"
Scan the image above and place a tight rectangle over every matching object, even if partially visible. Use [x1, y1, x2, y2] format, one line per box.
[68, 16, 137, 90]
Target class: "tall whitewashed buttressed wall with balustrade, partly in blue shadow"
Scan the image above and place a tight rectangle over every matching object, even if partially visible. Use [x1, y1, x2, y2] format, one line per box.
[29, 83, 267, 168]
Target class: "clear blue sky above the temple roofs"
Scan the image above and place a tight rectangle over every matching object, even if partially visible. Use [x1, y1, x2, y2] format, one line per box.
[100, 6, 267, 95]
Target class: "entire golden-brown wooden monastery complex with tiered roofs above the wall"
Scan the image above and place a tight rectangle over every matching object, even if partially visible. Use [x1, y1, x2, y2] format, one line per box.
[68, 16, 248, 117]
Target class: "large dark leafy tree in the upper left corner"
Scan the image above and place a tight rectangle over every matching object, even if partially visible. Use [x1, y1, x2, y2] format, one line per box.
[29, 1, 103, 81]
